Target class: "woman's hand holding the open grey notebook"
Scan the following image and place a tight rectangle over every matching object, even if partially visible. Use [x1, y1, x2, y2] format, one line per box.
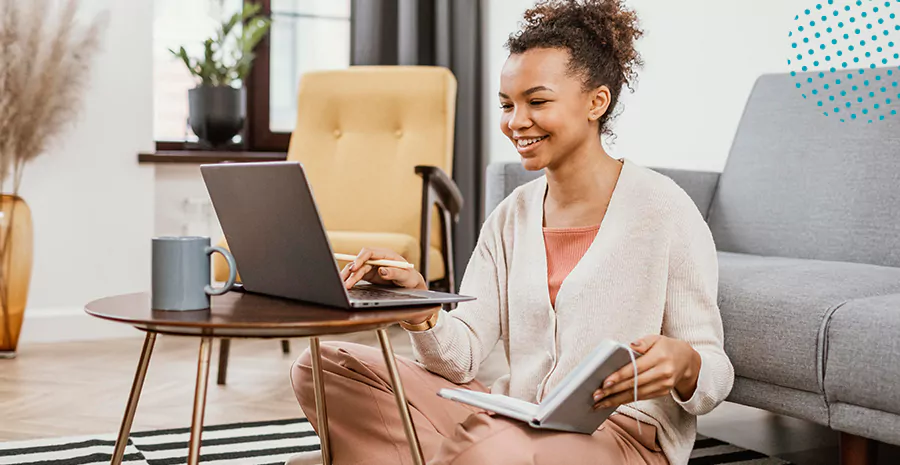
[594, 334, 700, 409]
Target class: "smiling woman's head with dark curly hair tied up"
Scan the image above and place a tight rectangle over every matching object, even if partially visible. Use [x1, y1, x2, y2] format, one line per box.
[499, 1, 643, 170]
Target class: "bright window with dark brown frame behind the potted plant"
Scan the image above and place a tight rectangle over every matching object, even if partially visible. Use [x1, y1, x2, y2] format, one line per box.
[153, 0, 351, 151]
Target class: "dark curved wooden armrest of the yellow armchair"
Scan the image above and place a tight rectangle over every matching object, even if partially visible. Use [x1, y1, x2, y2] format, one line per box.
[415, 165, 463, 292]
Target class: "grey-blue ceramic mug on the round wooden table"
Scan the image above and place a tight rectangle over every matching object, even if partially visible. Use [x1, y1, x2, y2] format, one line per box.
[151, 236, 237, 310]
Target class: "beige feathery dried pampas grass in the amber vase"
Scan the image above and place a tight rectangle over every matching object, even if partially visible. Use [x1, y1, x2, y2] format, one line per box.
[0, 0, 106, 195]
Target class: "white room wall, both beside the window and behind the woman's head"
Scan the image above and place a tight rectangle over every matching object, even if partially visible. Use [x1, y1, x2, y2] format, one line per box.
[14, 0, 880, 344]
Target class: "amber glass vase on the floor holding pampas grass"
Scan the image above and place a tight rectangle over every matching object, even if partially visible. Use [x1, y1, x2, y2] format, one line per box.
[0, 195, 34, 358]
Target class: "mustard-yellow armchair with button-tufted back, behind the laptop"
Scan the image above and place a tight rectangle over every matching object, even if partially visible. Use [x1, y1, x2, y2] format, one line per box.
[214, 66, 462, 292]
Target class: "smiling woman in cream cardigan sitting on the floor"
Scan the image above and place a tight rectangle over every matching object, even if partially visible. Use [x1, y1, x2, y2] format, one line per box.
[292, 0, 734, 465]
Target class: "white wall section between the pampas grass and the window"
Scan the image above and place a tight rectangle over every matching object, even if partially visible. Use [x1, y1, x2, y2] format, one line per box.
[22, 0, 154, 344]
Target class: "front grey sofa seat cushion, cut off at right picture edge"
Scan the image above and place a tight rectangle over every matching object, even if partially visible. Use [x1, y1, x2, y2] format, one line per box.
[825, 294, 900, 414]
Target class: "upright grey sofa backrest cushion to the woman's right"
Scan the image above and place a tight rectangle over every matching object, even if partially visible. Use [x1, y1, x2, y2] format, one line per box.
[709, 68, 900, 266]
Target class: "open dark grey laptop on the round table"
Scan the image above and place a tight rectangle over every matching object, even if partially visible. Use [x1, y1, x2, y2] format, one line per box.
[200, 161, 474, 309]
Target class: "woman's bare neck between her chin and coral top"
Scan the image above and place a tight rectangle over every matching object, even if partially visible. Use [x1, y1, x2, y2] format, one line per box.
[546, 138, 622, 205]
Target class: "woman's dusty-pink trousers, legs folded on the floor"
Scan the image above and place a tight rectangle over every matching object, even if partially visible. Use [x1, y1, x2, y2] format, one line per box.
[291, 342, 668, 465]
